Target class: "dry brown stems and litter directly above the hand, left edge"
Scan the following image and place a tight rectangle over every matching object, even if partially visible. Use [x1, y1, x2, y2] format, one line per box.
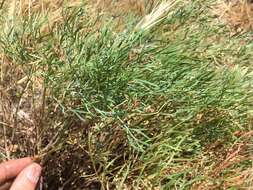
[0, 56, 43, 159]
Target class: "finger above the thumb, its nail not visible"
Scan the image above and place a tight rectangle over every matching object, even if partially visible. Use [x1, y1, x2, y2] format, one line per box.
[0, 158, 32, 184]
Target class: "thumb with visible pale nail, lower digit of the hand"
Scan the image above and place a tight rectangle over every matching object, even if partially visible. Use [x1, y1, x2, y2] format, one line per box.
[10, 163, 42, 190]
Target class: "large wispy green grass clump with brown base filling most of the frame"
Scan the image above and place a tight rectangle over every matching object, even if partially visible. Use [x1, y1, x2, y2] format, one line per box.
[0, 1, 253, 189]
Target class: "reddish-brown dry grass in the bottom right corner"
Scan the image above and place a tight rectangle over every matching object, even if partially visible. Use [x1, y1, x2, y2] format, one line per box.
[191, 131, 253, 190]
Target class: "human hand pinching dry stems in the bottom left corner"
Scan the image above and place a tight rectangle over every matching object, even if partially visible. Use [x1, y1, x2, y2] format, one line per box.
[0, 158, 42, 190]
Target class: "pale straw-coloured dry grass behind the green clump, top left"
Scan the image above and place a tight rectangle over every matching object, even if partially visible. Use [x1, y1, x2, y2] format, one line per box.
[2, 0, 158, 32]
